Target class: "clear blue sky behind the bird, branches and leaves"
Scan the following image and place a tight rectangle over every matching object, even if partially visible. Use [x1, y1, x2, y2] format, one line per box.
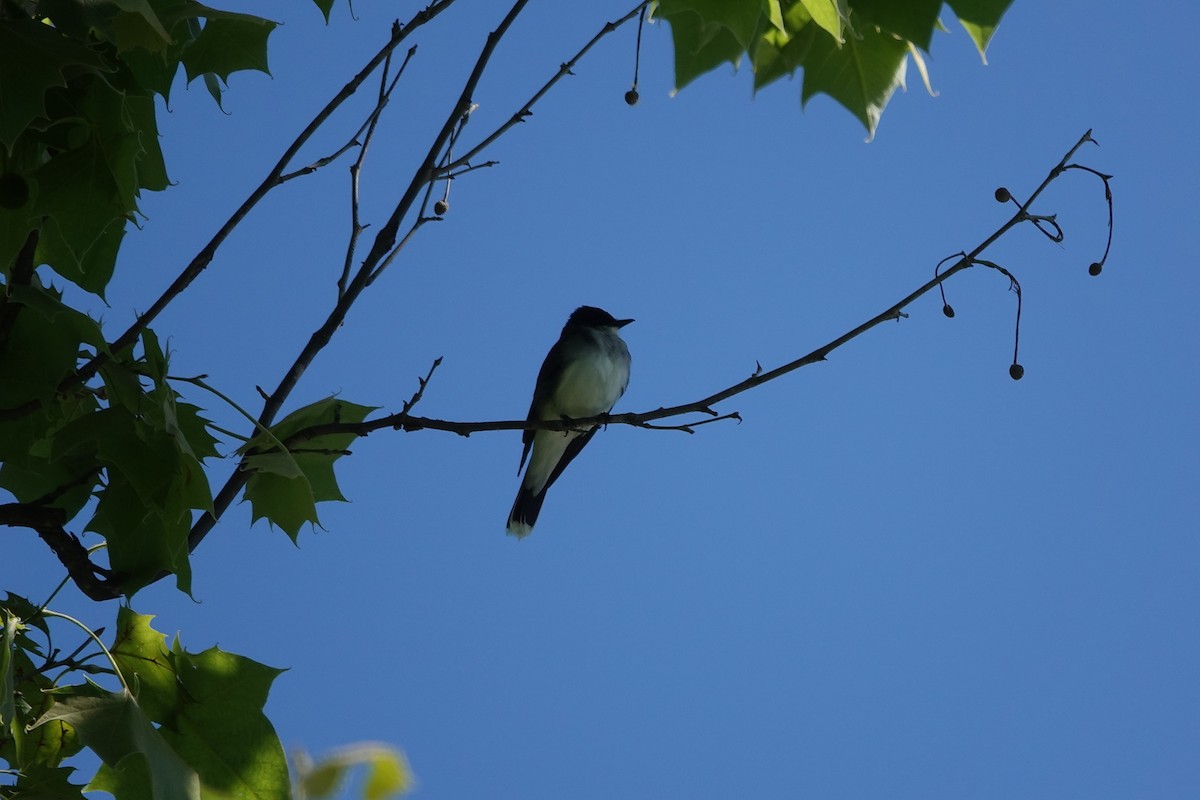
[0, 0, 1200, 800]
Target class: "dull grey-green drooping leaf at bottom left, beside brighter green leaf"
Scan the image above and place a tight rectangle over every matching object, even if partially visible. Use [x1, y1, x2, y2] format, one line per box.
[34, 682, 200, 800]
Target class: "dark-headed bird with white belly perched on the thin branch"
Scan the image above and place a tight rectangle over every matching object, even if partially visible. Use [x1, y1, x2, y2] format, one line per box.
[509, 306, 634, 536]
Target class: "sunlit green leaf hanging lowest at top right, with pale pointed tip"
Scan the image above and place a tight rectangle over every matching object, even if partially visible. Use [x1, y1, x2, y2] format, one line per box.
[800, 20, 908, 137]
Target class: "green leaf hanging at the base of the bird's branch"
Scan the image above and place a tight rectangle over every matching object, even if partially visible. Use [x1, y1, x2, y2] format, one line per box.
[242, 397, 374, 541]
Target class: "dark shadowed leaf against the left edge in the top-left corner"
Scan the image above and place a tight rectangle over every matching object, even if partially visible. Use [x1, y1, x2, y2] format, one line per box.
[0, 14, 112, 150]
